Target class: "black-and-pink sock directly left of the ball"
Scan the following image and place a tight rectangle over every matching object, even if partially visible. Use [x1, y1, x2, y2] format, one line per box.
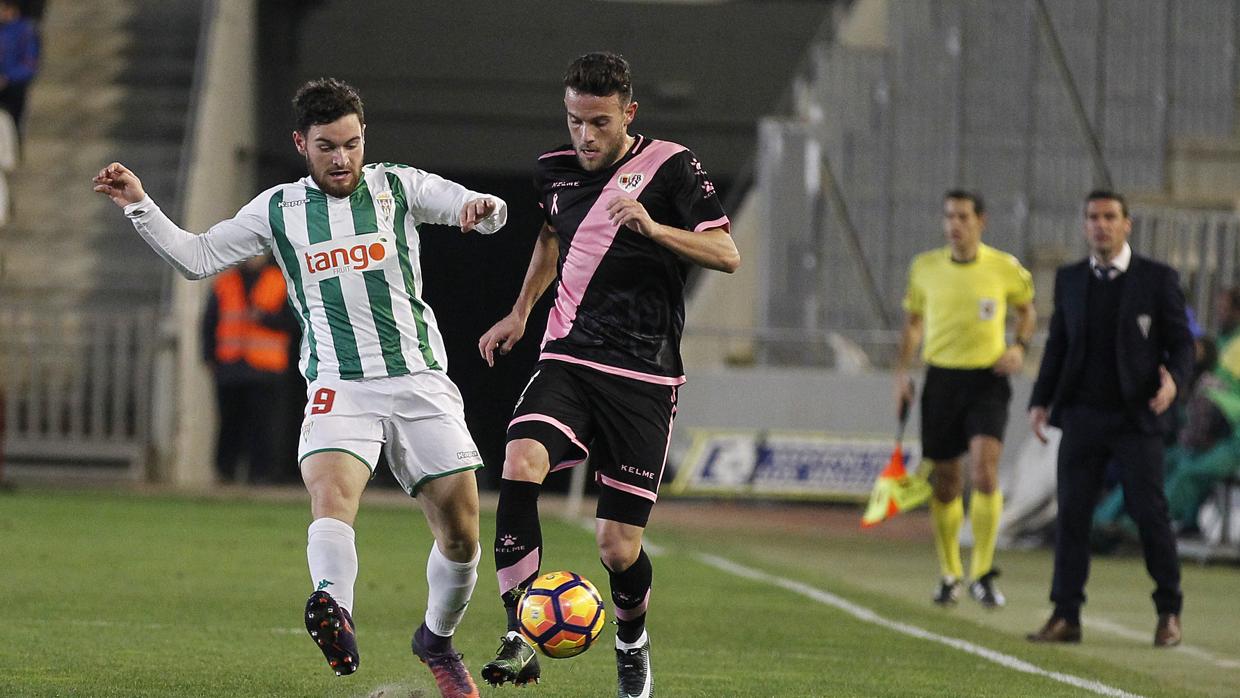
[495, 480, 542, 630]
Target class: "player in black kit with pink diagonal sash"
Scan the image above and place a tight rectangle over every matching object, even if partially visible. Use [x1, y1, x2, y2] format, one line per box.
[479, 53, 740, 698]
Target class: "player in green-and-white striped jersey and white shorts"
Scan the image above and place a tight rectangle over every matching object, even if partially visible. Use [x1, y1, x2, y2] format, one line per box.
[94, 78, 507, 697]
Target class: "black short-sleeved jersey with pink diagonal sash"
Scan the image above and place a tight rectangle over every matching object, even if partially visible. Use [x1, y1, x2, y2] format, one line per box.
[534, 135, 730, 386]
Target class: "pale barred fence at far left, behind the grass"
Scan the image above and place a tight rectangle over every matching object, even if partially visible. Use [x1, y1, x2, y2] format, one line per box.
[0, 307, 156, 480]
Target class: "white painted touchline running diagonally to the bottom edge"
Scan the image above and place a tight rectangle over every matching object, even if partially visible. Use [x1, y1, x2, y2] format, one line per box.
[696, 554, 1141, 698]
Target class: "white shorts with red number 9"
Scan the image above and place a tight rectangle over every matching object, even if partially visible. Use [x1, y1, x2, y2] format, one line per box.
[298, 371, 482, 497]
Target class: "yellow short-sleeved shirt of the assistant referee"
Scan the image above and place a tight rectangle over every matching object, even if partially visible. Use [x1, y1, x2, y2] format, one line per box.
[904, 244, 1033, 368]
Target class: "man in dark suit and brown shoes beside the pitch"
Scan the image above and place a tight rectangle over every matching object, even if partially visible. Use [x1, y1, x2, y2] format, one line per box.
[1028, 191, 1193, 647]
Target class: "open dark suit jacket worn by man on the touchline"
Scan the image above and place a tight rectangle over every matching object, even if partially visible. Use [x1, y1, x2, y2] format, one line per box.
[1029, 254, 1193, 433]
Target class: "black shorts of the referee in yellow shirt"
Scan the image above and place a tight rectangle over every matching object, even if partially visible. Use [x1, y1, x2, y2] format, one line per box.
[921, 366, 1012, 460]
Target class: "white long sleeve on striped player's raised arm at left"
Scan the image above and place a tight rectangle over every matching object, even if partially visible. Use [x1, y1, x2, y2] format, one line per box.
[125, 196, 272, 279]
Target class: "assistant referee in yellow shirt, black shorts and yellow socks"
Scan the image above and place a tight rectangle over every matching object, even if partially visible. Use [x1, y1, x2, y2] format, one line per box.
[895, 190, 1037, 607]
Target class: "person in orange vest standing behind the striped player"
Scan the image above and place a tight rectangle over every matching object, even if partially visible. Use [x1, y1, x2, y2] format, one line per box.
[202, 255, 298, 482]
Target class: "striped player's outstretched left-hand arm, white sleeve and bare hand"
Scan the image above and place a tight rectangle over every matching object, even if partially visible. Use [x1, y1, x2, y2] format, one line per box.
[93, 162, 270, 279]
